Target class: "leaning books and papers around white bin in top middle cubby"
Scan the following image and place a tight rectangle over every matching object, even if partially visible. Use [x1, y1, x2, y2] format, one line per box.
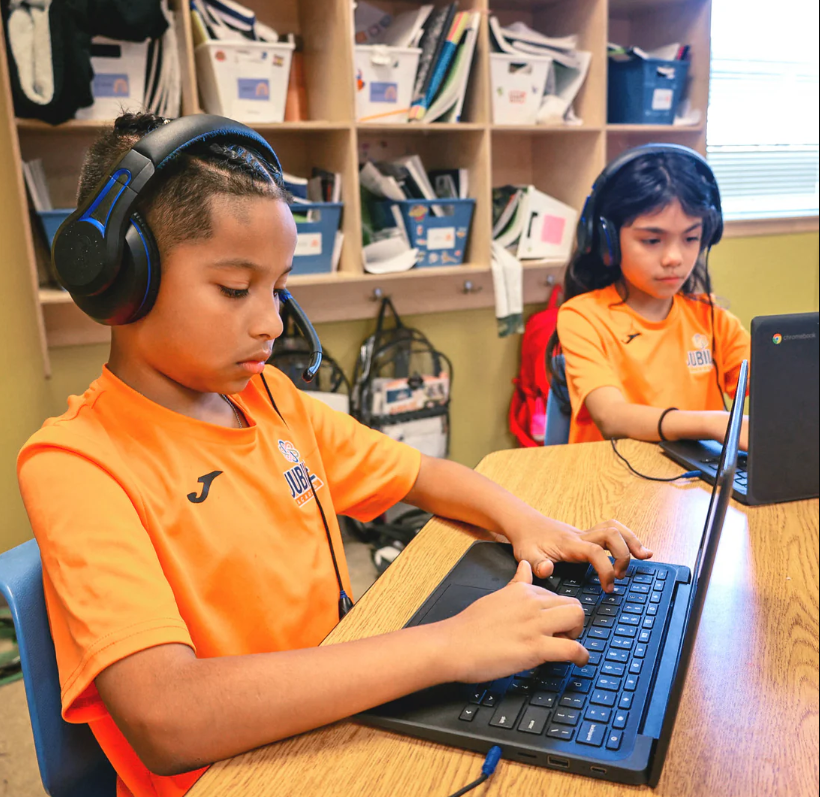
[356, 2, 481, 122]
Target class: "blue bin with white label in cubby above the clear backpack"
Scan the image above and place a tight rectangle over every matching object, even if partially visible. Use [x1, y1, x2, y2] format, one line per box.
[382, 199, 475, 267]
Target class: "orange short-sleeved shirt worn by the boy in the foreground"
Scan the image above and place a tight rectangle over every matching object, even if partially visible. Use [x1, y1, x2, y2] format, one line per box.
[18, 367, 421, 797]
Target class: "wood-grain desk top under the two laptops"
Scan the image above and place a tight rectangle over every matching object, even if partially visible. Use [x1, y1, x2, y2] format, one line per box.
[189, 442, 820, 797]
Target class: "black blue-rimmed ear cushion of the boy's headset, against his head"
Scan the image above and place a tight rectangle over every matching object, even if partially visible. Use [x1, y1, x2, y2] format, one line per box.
[74, 213, 160, 326]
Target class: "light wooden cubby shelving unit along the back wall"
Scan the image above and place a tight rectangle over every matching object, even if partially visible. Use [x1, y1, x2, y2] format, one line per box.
[0, 0, 711, 372]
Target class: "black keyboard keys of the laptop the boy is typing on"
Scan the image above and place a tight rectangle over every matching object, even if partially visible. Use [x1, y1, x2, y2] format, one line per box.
[459, 562, 671, 750]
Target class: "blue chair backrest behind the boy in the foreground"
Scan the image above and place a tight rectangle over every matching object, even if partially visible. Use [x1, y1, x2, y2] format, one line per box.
[0, 540, 116, 797]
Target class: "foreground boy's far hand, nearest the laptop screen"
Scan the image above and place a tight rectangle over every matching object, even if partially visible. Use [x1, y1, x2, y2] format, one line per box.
[505, 515, 652, 592]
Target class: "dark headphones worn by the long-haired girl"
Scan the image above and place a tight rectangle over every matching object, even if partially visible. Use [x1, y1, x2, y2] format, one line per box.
[577, 144, 723, 268]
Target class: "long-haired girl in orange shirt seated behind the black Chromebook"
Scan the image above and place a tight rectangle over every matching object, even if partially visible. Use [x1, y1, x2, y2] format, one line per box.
[547, 144, 749, 449]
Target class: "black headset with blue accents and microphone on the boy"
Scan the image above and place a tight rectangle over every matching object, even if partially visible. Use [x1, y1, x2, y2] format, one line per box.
[51, 114, 322, 381]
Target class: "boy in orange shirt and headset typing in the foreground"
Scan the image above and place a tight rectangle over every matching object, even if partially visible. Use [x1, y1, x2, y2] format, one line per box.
[18, 115, 651, 797]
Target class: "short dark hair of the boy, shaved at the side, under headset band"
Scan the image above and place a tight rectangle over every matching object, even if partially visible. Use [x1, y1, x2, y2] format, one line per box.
[77, 113, 290, 252]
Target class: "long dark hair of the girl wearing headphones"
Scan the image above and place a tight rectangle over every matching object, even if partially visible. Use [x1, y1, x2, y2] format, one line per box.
[546, 152, 718, 392]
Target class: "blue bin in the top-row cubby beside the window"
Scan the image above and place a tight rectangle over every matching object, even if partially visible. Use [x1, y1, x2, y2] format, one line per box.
[607, 58, 689, 125]
